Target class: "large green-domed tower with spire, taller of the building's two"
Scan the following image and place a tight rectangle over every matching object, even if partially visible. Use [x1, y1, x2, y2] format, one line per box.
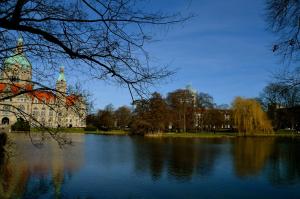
[2, 37, 32, 85]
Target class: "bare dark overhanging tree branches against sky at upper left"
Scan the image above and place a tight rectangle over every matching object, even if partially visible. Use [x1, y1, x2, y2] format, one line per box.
[0, 0, 189, 146]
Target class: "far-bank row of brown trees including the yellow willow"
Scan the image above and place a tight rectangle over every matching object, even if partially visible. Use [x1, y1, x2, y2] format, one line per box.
[87, 87, 273, 134]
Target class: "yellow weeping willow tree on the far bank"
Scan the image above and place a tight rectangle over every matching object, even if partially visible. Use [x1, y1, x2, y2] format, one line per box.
[232, 97, 273, 135]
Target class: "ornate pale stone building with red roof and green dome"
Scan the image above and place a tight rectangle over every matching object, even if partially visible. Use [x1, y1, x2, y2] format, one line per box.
[0, 38, 87, 128]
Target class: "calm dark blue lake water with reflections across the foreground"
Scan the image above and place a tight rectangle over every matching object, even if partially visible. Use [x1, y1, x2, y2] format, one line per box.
[0, 135, 300, 199]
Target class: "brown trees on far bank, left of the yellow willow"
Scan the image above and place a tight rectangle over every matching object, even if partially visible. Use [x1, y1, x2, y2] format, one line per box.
[87, 88, 232, 134]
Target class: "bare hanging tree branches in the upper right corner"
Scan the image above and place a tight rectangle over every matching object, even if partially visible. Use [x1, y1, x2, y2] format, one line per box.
[266, 0, 300, 97]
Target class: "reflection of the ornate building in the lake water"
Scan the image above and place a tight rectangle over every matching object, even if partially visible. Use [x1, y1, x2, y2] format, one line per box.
[0, 134, 84, 199]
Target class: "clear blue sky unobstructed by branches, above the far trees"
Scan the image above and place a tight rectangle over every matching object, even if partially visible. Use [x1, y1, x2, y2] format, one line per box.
[75, 0, 281, 109]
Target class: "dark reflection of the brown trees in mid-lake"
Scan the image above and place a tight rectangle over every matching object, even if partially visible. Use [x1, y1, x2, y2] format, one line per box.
[133, 138, 223, 181]
